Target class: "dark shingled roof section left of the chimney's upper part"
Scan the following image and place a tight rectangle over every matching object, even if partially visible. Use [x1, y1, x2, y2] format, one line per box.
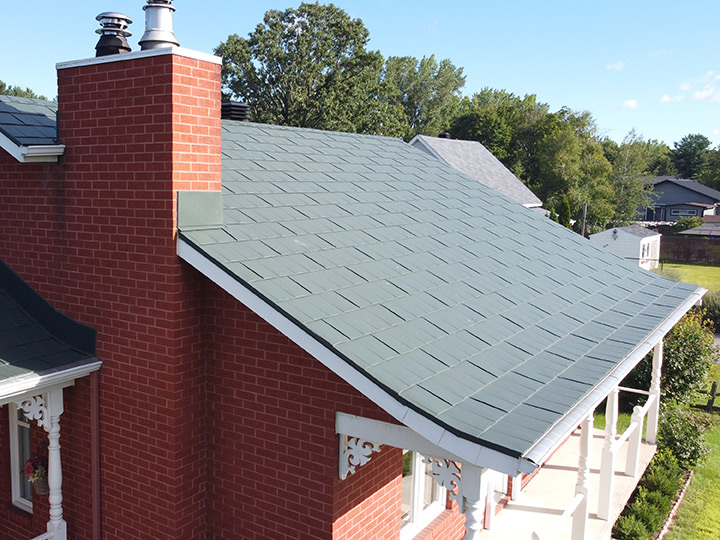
[0, 95, 58, 146]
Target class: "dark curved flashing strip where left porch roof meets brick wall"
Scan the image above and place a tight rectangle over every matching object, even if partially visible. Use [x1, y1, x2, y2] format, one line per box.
[0, 259, 97, 356]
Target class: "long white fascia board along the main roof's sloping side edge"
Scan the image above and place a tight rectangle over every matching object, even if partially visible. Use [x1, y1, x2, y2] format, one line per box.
[177, 237, 536, 475]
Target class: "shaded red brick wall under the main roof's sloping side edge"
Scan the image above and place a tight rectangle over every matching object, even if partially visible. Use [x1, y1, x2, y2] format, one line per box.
[206, 286, 401, 540]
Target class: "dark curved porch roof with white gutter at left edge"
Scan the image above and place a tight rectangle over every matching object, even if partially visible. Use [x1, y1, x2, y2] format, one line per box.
[0, 261, 100, 405]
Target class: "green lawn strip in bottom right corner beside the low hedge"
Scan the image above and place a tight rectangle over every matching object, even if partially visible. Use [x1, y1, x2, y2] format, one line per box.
[665, 366, 720, 540]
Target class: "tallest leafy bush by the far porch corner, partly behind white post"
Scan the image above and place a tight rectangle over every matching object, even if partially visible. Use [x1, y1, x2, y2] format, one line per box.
[627, 311, 718, 402]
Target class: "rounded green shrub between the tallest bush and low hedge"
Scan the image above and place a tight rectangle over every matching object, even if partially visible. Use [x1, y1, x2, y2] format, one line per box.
[658, 403, 710, 469]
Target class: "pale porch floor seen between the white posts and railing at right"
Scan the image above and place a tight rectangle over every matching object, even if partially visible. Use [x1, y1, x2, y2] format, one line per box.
[480, 429, 655, 540]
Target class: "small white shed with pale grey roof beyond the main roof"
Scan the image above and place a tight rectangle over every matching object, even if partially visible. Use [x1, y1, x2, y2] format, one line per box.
[590, 225, 662, 270]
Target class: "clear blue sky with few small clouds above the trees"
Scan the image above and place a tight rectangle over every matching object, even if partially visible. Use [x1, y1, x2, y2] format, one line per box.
[0, 0, 720, 147]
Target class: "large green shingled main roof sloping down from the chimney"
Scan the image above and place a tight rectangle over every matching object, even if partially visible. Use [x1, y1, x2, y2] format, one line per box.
[181, 121, 701, 464]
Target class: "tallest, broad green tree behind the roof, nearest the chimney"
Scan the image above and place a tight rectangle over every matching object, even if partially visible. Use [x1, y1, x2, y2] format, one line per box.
[215, 3, 388, 132]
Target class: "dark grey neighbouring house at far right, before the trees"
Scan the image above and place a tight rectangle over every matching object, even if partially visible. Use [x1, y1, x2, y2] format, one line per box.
[645, 176, 720, 221]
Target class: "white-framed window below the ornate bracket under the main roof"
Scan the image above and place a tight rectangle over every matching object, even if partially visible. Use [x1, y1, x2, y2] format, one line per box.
[400, 450, 446, 540]
